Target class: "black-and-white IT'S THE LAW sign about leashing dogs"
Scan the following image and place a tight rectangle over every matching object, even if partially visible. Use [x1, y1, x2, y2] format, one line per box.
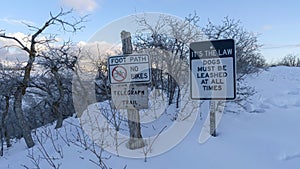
[190, 39, 236, 100]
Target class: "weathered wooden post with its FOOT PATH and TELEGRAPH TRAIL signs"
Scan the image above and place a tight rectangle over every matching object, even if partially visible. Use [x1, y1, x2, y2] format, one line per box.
[108, 31, 151, 149]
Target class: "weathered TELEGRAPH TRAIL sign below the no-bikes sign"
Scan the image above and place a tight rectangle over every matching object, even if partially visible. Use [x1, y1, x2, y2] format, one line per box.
[111, 84, 148, 109]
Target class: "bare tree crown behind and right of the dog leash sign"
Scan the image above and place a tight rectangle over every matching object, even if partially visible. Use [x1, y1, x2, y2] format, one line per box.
[202, 17, 266, 80]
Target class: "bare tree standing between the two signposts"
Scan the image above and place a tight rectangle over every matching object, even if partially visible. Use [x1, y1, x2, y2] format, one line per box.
[133, 14, 203, 107]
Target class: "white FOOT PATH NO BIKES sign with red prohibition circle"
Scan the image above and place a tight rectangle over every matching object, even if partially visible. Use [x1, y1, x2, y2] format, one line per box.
[108, 54, 151, 84]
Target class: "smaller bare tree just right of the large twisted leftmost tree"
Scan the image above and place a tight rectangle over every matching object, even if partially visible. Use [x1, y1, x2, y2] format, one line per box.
[37, 41, 78, 128]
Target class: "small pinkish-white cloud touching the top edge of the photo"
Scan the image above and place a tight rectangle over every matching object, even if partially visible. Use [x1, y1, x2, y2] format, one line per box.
[60, 0, 98, 13]
